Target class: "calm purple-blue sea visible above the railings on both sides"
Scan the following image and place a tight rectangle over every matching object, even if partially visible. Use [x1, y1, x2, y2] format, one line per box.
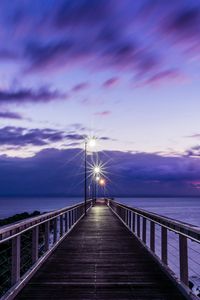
[0, 197, 200, 226]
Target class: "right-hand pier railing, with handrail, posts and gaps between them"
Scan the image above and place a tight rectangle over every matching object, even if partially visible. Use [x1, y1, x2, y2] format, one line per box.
[107, 199, 200, 299]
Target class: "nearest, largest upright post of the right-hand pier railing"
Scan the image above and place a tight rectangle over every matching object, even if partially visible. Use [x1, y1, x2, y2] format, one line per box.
[179, 234, 188, 286]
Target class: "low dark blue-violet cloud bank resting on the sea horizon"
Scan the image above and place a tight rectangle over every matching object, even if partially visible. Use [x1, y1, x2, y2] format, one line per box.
[0, 149, 200, 196]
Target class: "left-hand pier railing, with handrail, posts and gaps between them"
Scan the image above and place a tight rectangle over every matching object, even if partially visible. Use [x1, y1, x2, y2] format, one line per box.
[0, 200, 94, 299]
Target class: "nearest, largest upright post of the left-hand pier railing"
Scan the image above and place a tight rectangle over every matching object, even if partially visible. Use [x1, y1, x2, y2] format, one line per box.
[11, 235, 21, 285]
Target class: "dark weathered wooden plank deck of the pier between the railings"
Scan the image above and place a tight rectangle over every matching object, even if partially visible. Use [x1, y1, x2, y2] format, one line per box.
[15, 204, 184, 300]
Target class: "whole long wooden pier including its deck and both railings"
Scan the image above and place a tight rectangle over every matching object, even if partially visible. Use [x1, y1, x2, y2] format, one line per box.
[0, 199, 200, 300]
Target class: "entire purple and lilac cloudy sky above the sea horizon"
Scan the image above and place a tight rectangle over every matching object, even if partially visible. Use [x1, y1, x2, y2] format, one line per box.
[0, 0, 200, 196]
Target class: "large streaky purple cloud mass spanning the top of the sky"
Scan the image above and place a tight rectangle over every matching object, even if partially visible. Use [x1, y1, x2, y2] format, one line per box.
[0, 0, 200, 87]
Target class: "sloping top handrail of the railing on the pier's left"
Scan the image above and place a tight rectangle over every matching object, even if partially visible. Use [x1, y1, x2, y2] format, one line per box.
[0, 199, 92, 243]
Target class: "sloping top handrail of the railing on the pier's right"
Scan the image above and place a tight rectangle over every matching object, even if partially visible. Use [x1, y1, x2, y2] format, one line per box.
[108, 199, 200, 243]
